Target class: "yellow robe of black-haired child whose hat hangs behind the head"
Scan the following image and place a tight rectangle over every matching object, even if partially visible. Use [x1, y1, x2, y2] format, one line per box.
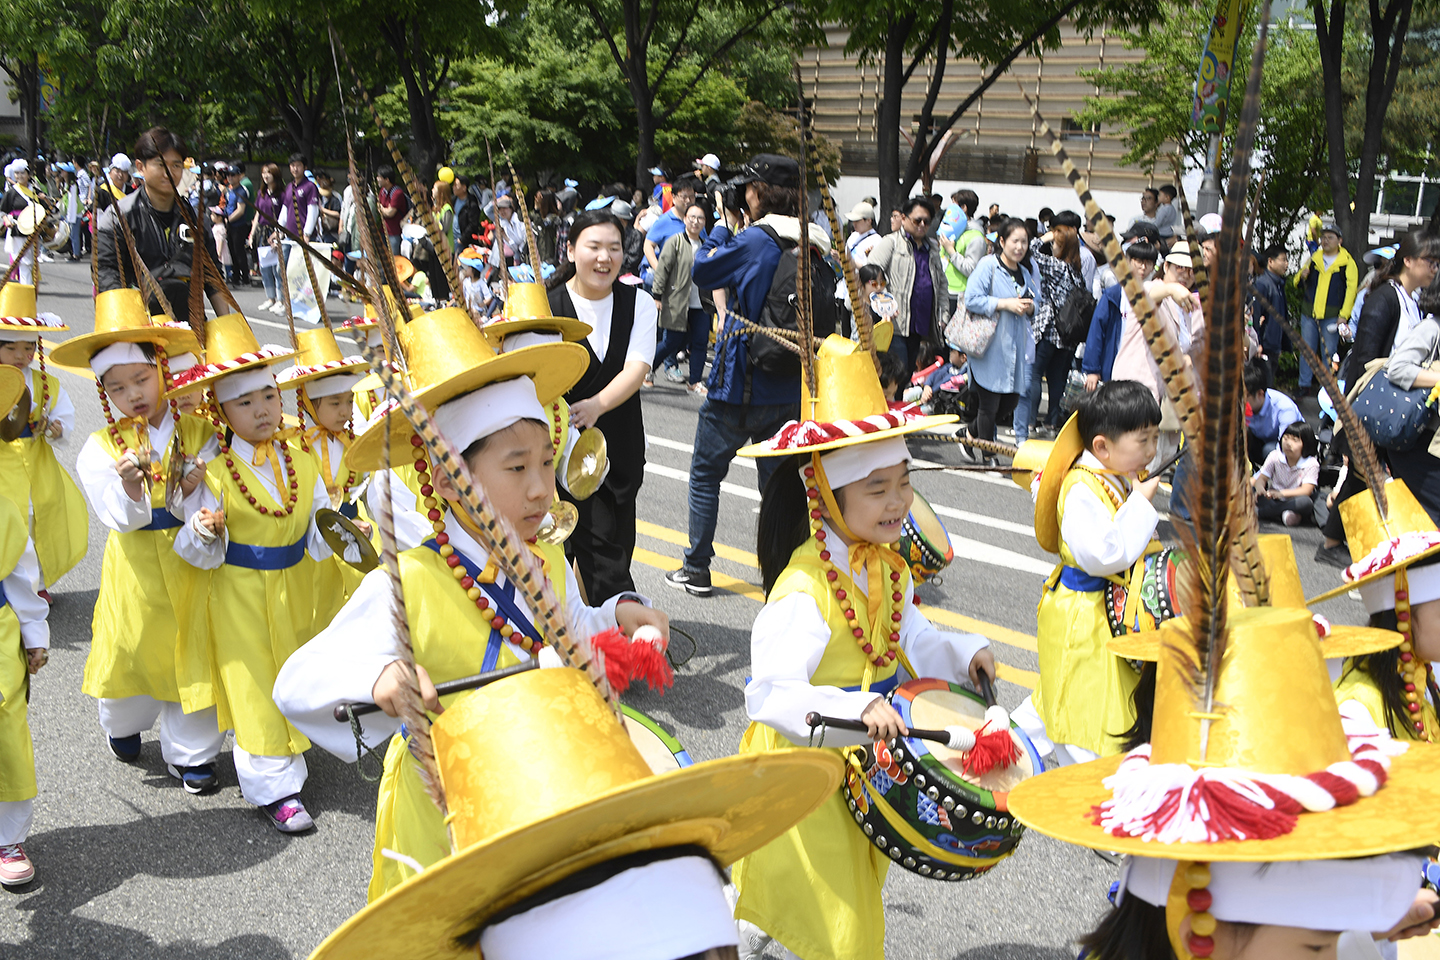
[1031, 469, 1139, 757]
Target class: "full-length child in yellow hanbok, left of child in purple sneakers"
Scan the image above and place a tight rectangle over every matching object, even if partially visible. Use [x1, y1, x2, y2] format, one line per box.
[53, 289, 225, 793]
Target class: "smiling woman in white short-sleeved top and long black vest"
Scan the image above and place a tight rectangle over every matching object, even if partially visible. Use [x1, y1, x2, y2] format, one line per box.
[550, 209, 655, 597]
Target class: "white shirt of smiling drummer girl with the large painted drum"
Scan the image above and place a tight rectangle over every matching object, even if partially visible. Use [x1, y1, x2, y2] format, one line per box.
[744, 524, 989, 747]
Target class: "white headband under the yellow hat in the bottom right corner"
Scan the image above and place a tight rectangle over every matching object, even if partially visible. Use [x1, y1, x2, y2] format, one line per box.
[1120, 852, 1423, 933]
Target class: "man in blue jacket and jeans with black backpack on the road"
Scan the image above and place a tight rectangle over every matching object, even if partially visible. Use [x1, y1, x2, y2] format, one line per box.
[665, 154, 835, 596]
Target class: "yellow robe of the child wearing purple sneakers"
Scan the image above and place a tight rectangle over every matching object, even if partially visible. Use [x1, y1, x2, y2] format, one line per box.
[206, 445, 318, 757]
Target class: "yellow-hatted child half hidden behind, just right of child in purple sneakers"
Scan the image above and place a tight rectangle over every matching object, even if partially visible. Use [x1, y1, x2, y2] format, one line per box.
[276, 327, 370, 629]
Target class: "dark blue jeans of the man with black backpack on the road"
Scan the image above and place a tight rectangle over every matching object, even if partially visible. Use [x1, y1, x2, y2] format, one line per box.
[685, 399, 799, 570]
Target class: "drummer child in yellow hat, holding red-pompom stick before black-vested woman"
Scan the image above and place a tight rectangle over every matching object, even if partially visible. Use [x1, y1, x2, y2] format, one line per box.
[275, 308, 667, 900]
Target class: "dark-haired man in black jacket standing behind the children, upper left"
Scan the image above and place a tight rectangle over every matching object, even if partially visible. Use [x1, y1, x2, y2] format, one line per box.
[95, 127, 226, 320]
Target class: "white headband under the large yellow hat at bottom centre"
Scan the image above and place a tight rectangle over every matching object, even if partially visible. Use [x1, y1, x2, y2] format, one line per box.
[480, 856, 740, 960]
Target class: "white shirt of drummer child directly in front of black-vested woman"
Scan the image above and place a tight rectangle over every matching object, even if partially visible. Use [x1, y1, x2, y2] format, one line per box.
[274, 511, 648, 763]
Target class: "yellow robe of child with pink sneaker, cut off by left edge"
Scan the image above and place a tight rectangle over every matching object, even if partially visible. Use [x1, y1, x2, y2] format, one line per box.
[0, 495, 37, 803]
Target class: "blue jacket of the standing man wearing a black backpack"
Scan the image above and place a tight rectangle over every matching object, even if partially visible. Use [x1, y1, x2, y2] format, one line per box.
[691, 217, 801, 404]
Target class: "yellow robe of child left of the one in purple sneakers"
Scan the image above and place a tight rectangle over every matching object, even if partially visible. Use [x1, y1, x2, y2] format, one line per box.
[81, 415, 215, 712]
